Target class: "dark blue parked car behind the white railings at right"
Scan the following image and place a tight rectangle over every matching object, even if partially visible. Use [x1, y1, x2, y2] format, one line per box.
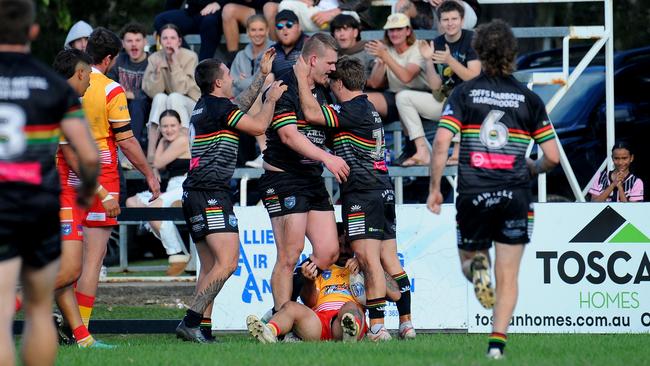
[515, 47, 650, 201]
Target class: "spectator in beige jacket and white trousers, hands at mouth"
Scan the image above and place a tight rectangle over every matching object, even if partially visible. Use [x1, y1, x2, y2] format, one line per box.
[142, 24, 201, 161]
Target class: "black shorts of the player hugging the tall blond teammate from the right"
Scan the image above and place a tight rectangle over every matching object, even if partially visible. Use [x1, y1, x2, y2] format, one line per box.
[341, 189, 396, 241]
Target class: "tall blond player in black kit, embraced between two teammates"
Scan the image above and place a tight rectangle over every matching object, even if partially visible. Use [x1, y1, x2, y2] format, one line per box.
[260, 33, 349, 311]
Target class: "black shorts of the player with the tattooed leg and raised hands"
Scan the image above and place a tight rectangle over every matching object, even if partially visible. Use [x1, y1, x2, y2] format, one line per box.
[182, 190, 239, 242]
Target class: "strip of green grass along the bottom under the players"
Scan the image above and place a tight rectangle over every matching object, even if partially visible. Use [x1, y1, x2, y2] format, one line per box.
[52, 334, 650, 366]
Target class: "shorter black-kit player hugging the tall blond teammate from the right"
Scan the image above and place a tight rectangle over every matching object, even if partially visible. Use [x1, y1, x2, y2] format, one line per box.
[294, 56, 415, 341]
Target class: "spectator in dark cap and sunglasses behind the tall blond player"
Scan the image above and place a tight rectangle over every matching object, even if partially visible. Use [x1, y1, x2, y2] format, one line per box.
[271, 10, 307, 77]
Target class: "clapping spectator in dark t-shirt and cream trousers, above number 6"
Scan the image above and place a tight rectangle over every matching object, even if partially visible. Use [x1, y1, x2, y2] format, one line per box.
[395, 0, 481, 166]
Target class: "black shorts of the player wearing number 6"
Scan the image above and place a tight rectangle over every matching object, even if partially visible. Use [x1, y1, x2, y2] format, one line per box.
[456, 189, 533, 251]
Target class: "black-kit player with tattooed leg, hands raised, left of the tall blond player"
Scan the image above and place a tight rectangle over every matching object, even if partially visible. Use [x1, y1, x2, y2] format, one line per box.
[176, 59, 287, 343]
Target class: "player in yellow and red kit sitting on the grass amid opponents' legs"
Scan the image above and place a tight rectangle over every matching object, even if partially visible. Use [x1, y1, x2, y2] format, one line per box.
[246, 224, 400, 343]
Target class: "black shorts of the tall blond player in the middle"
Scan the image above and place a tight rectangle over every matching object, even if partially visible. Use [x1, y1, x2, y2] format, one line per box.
[259, 171, 334, 217]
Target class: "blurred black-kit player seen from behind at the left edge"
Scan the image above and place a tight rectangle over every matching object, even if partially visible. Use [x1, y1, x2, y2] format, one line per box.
[0, 0, 99, 365]
